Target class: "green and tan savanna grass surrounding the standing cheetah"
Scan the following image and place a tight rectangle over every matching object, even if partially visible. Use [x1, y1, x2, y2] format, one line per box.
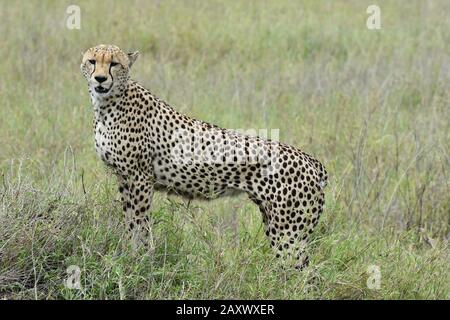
[0, 0, 450, 299]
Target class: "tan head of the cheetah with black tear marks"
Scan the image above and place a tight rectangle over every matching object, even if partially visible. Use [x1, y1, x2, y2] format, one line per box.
[80, 44, 139, 98]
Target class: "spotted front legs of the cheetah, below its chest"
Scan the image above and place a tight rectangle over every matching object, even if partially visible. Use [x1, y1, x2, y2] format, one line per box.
[119, 174, 153, 250]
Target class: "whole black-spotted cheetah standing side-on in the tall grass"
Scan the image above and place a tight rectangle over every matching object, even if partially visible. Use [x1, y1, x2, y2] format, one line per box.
[80, 44, 327, 269]
